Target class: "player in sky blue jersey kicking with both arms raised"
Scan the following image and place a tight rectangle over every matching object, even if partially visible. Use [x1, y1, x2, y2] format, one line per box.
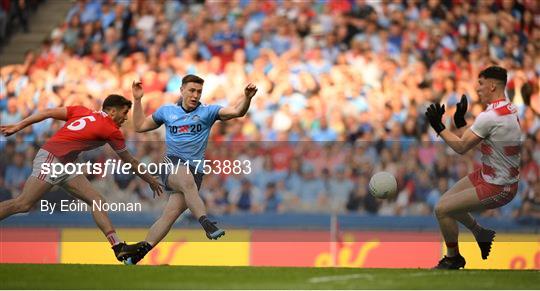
[126, 75, 257, 264]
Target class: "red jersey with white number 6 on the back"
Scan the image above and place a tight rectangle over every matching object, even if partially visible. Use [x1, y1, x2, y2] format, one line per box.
[42, 106, 127, 163]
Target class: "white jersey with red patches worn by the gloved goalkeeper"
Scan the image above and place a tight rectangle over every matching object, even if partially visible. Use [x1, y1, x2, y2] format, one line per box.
[471, 99, 521, 185]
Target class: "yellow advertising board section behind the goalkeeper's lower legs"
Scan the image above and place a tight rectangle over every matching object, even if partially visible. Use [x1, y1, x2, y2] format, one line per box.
[443, 233, 540, 270]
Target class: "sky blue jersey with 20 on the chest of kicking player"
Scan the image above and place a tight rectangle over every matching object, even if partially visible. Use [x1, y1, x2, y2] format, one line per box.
[152, 104, 222, 170]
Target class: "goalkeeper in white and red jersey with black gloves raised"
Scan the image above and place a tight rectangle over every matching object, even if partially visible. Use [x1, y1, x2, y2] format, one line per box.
[426, 66, 521, 269]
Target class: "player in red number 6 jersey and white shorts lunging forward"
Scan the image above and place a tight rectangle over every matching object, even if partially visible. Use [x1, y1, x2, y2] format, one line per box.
[0, 94, 163, 261]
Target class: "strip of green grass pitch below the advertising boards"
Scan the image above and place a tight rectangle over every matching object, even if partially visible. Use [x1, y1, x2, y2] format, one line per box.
[0, 264, 540, 289]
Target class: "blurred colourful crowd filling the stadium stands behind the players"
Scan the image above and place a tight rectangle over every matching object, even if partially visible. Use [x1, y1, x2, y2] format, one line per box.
[0, 0, 540, 219]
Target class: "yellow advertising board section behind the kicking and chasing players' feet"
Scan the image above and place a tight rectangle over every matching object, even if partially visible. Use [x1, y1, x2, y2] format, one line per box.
[60, 229, 250, 266]
